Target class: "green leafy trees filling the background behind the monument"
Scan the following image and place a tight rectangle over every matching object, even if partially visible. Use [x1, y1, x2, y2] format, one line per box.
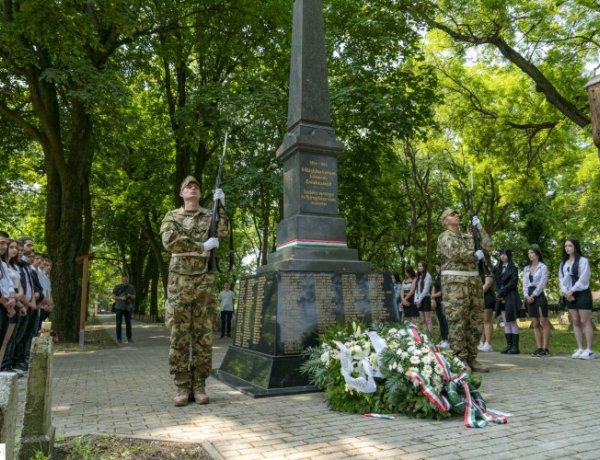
[0, 0, 600, 340]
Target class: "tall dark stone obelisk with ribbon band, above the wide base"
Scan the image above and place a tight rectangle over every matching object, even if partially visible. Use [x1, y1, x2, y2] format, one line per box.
[261, 0, 370, 273]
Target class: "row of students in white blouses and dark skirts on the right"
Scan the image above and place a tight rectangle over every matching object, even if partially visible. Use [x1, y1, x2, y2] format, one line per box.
[394, 238, 595, 360]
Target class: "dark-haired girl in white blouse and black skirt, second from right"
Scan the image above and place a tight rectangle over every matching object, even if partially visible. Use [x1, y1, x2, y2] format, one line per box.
[523, 248, 550, 357]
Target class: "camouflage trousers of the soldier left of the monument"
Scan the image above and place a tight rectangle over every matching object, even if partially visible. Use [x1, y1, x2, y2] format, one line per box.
[165, 273, 215, 385]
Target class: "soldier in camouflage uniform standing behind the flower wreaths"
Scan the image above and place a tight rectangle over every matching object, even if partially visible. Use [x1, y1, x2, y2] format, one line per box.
[437, 209, 493, 372]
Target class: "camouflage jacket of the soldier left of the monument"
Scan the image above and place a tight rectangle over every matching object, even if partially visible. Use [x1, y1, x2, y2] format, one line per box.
[160, 207, 229, 275]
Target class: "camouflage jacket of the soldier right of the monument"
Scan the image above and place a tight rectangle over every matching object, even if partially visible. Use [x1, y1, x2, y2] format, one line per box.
[437, 229, 494, 272]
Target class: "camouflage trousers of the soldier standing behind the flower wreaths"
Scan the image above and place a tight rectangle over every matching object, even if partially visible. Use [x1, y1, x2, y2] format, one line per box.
[442, 275, 483, 363]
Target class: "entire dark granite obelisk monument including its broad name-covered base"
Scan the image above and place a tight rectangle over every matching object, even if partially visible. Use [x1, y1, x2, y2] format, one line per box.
[215, 0, 398, 396]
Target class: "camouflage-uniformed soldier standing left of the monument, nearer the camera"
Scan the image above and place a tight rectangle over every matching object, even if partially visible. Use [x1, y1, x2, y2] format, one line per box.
[160, 176, 229, 406]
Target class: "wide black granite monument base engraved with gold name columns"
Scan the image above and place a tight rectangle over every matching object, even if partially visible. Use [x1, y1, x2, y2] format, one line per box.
[214, 271, 399, 397]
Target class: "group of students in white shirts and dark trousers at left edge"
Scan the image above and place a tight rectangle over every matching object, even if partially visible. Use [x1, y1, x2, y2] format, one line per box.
[0, 231, 54, 377]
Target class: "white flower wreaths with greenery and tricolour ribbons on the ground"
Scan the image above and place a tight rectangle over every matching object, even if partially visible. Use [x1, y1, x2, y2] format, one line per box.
[302, 322, 506, 426]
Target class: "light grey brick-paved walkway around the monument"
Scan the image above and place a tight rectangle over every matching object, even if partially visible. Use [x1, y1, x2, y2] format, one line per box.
[37, 316, 600, 460]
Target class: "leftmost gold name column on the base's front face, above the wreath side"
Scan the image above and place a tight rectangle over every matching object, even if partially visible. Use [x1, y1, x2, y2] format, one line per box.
[280, 273, 305, 354]
